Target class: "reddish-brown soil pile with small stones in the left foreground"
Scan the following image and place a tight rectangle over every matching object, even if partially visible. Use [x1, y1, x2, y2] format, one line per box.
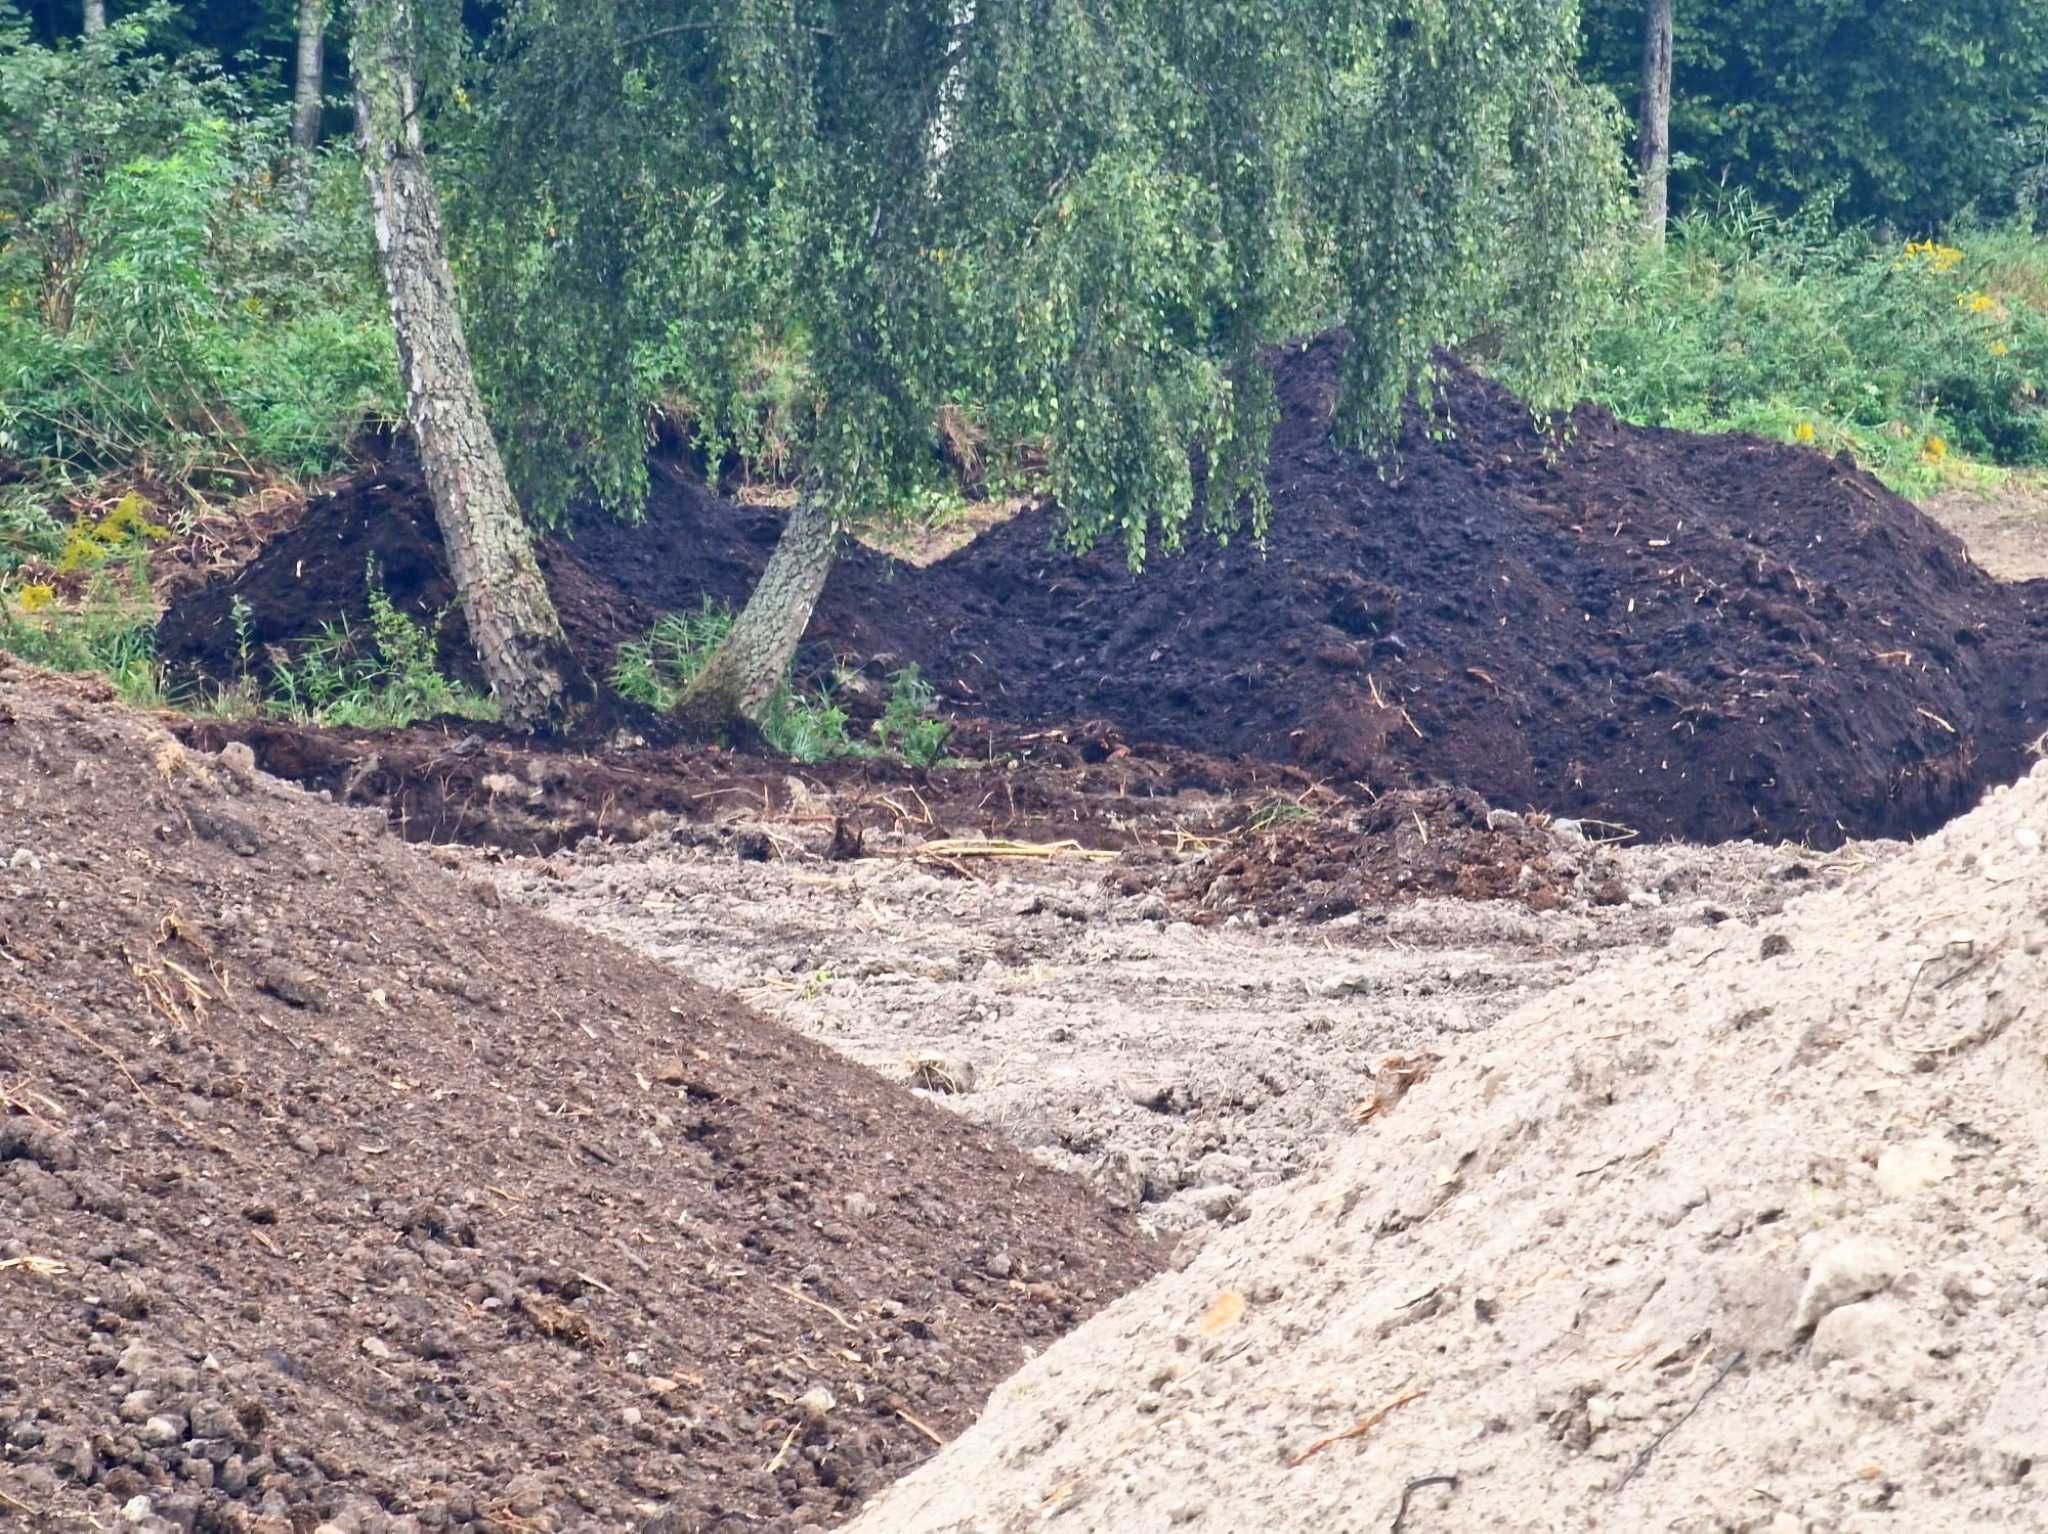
[0, 662, 1153, 1534]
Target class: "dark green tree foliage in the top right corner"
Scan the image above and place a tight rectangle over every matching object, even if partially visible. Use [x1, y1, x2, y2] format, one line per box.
[1585, 0, 2048, 231]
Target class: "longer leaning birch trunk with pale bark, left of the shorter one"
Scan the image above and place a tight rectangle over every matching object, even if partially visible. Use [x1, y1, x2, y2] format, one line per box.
[348, 0, 590, 727]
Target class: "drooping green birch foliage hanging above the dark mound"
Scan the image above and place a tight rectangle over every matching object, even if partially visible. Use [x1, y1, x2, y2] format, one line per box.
[471, 0, 1618, 561]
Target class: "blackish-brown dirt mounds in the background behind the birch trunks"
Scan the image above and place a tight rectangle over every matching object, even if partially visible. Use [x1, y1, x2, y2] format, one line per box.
[164, 338, 2048, 846]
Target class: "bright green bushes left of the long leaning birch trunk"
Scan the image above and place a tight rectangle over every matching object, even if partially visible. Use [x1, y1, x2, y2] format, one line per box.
[0, 4, 397, 520]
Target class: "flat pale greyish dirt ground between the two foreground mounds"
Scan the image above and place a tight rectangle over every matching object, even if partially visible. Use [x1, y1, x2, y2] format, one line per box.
[475, 805, 1882, 1231]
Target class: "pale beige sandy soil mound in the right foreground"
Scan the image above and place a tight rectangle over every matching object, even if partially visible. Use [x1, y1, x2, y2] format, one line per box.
[856, 768, 2048, 1534]
